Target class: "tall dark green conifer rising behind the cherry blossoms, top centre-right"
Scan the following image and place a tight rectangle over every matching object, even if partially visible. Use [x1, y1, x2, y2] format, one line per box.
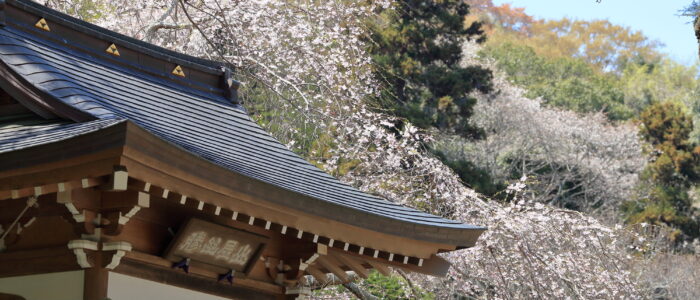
[369, 0, 492, 136]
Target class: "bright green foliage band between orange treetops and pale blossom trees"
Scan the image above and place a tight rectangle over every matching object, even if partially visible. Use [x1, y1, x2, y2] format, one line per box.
[484, 43, 633, 120]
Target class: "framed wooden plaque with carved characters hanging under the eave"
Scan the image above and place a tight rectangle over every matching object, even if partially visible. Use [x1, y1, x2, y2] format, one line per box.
[163, 218, 269, 275]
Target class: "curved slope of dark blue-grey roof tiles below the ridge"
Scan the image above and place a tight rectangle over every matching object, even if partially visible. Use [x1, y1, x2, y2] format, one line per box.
[0, 1, 483, 244]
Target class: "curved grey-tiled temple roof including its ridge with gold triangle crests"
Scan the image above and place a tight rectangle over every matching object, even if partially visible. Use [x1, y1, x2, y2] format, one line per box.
[0, 0, 484, 247]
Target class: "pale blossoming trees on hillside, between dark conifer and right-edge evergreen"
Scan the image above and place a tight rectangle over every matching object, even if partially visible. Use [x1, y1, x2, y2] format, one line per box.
[434, 43, 645, 220]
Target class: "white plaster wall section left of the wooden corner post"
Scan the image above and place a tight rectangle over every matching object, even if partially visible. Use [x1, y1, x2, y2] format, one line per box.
[0, 271, 84, 300]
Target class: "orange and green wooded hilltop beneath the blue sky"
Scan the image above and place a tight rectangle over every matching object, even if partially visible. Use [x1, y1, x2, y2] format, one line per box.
[468, 0, 700, 123]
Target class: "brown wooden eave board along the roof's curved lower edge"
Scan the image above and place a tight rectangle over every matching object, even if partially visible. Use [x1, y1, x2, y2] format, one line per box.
[0, 121, 485, 253]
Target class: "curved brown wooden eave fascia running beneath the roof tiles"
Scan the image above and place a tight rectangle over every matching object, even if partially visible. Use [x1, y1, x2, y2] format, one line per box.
[0, 121, 481, 259]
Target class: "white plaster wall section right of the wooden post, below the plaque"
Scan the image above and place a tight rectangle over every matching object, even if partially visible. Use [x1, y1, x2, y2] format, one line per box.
[107, 272, 227, 300]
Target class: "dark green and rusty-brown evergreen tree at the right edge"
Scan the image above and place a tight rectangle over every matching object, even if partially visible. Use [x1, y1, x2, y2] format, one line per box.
[624, 101, 700, 237]
